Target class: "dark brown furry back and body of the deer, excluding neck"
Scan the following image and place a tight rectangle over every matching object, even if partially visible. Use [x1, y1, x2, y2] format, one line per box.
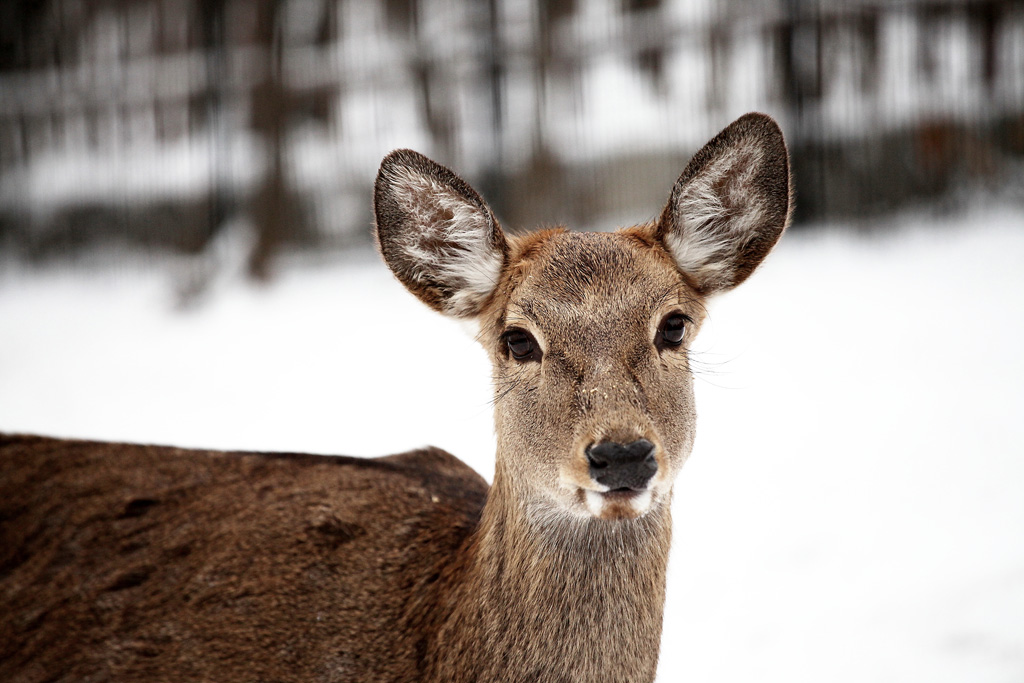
[0, 435, 487, 683]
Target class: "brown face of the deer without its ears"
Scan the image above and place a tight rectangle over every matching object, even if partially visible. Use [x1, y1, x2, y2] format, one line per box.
[481, 230, 703, 517]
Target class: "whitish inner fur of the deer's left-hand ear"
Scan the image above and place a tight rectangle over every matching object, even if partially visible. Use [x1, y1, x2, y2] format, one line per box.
[392, 167, 502, 316]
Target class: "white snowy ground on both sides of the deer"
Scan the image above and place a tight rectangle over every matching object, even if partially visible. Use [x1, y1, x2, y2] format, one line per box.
[0, 206, 1024, 683]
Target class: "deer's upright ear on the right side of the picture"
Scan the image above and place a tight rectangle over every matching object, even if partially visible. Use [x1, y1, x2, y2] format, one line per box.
[655, 114, 792, 294]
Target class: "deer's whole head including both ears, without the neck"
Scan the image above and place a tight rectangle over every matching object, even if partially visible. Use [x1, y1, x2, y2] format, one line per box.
[375, 115, 790, 519]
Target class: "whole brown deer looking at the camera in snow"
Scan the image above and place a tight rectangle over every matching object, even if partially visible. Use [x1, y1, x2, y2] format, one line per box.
[0, 114, 792, 683]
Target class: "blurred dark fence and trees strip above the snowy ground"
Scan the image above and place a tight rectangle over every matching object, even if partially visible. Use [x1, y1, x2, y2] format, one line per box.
[0, 0, 1024, 278]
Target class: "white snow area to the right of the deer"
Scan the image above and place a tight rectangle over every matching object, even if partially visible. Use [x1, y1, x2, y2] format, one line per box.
[662, 208, 1024, 682]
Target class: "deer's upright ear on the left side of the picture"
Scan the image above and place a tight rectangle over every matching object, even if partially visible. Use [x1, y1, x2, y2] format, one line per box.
[374, 150, 508, 317]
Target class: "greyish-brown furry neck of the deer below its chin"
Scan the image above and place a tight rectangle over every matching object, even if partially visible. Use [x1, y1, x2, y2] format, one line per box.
[434, 472, 671, 681]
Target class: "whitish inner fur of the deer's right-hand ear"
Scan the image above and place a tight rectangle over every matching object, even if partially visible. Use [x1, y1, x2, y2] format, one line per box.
[665, 144, 764, 290]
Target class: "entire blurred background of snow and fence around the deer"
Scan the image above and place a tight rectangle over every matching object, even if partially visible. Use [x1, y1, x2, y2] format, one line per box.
[0, 0, 1024, 683]
